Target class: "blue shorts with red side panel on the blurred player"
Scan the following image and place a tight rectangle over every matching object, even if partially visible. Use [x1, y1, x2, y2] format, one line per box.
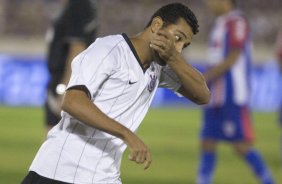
[201, 104, 254, 142]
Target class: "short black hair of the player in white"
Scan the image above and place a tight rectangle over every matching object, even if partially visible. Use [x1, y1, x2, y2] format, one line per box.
[146, 3, 199, 34]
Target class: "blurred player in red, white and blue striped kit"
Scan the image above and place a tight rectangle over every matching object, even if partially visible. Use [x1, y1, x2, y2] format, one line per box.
[197, 0, 274, 184]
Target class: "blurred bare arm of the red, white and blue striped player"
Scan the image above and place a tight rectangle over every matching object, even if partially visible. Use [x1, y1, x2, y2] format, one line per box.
[204, 49, 240, 82]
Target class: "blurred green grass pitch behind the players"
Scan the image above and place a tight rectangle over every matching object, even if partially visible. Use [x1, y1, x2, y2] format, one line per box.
[0, 107, 282, 184]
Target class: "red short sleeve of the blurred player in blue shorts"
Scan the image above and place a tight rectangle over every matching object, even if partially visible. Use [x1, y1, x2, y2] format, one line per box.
[227, 17, 249, 49]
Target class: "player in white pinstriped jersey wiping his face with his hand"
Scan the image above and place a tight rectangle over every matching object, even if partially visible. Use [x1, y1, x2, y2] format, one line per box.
[22, 3, 210, 184]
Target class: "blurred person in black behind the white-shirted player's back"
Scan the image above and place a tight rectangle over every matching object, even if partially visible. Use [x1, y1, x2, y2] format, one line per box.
[45, 0, 97, 131]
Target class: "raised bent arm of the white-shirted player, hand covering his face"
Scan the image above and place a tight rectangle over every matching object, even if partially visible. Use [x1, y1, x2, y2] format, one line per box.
[150, 30, 210, 105]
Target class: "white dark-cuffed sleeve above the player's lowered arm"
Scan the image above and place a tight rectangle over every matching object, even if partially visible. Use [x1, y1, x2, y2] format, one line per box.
[67, 39, 119, 99]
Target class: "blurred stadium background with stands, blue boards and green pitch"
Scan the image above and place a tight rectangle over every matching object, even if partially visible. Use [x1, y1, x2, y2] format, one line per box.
[0, 0, 282, 184]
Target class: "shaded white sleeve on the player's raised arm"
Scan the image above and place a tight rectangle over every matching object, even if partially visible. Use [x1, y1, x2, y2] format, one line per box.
[159, 66, 181, 92]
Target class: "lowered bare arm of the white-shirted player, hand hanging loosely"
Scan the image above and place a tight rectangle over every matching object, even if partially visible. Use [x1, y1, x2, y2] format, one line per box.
[62, 87, 152, 169]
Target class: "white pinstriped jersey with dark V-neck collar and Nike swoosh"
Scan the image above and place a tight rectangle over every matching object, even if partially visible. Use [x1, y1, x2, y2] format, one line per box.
[30, 34, 180, 184]
